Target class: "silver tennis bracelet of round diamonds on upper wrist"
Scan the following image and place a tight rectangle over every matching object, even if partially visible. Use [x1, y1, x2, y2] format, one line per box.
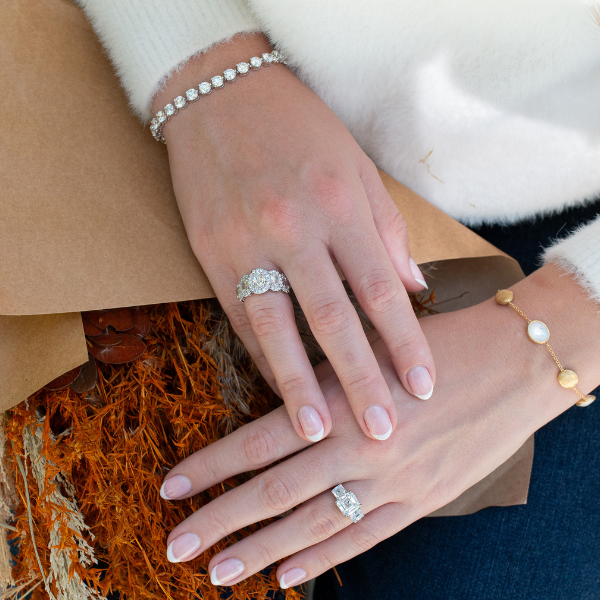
[150, 50, 287, 144]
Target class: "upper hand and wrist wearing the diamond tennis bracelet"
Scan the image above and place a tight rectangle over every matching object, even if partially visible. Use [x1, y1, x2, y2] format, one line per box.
[153, 34, 435, 441]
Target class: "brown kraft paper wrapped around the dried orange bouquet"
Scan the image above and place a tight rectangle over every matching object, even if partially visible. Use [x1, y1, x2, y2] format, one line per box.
[0, 0, 533, 515]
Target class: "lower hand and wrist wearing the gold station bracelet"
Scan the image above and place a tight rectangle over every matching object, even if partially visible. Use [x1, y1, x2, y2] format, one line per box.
[161, 264, 600, 587]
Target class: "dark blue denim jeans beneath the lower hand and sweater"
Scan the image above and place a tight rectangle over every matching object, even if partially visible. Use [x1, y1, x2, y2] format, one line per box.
[314, 203, 600, 600]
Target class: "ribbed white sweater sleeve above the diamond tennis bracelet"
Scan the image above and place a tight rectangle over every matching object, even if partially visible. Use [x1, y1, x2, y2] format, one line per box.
[78, 0, 260, 120]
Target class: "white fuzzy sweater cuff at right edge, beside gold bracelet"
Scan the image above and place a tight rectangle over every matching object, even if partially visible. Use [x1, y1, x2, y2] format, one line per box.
[543, 215, 600, 304]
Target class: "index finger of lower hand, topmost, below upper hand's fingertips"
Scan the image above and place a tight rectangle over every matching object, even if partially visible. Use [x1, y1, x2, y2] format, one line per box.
[160, 406, 308, 500]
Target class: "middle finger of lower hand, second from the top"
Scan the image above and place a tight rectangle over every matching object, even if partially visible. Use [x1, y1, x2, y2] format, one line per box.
[167, 440, 350, 562]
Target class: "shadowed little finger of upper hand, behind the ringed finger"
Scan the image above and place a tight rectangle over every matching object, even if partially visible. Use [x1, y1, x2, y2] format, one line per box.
[205, 264, 281, 397]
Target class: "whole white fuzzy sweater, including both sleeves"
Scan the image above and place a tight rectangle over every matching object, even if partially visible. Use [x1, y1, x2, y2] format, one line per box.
[79, 0, 600, 302]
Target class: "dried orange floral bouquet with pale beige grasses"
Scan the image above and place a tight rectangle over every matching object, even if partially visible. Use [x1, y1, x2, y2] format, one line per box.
[0, 294, 434, 600]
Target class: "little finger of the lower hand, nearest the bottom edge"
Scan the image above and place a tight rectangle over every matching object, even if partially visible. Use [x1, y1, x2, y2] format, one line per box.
[277, 503, 418, 589]
